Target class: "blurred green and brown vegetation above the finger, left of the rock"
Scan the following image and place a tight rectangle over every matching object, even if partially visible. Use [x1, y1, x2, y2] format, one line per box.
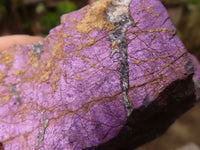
[0, 0, 88, 36]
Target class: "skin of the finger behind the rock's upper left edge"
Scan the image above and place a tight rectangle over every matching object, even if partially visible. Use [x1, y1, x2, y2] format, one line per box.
[0, 35, 43, 52]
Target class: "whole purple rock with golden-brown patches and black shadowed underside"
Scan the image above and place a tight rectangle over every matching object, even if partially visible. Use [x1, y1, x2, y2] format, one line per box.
[0, 0, 200, 150]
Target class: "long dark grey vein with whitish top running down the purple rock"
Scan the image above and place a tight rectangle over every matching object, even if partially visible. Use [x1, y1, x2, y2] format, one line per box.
[104, 0, 135, 118]
